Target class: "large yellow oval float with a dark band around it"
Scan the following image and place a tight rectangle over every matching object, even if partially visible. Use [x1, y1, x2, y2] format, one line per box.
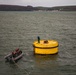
[33, 40, 58, 54]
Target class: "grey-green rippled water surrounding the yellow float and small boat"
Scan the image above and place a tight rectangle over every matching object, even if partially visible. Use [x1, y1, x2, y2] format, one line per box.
[0, 11, 76, 75]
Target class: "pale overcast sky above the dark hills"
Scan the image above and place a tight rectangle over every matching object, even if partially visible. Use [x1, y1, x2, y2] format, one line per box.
[0, 0, 76, 7]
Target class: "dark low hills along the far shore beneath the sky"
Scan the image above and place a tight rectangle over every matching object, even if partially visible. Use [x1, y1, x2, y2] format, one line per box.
[0, 5, 76, 11]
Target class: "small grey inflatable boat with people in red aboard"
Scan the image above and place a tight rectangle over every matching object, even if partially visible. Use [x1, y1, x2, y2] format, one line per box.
[5, 49, 23, 63]
